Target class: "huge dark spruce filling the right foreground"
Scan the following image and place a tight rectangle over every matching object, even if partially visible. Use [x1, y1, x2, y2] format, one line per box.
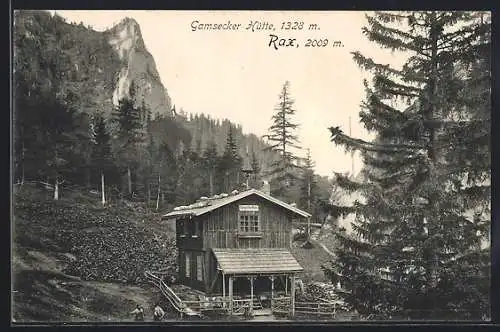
[325, 12, 491, 319]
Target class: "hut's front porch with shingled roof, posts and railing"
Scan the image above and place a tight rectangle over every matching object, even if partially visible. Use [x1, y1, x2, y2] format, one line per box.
[213, 249, 303, 316]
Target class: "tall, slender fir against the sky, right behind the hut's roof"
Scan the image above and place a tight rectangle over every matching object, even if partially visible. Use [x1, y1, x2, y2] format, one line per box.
[264, 81, 300, 198]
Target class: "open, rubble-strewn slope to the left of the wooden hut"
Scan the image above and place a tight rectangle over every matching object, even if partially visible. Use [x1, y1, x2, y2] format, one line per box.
[12, 184, 177, 321]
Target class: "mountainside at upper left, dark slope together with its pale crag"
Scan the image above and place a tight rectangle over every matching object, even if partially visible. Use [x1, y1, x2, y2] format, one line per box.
[14, 11, 171, 120]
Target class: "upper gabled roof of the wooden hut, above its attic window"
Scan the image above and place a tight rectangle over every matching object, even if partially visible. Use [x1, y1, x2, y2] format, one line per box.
[162, 189, 311, 220]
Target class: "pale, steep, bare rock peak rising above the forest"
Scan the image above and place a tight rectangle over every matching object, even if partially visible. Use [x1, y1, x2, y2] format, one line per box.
[104, 18, 172, 116]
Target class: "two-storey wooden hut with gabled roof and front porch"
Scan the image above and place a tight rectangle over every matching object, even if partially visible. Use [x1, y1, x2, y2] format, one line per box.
[162, 189, 310, 313]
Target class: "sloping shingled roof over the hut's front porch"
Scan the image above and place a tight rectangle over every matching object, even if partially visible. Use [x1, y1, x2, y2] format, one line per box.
[212, 249, 303, 274]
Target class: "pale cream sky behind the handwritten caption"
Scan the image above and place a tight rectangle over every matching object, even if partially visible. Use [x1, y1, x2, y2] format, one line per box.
[49, 10, 402, 176]
